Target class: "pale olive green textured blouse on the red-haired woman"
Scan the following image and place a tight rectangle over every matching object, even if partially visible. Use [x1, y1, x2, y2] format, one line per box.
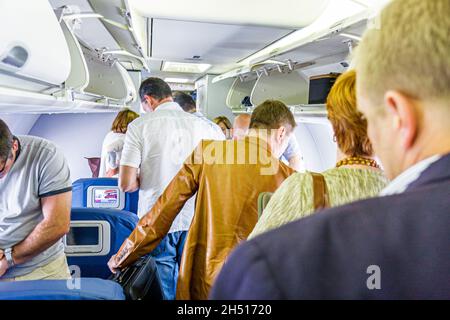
[248, 167, 388, 239]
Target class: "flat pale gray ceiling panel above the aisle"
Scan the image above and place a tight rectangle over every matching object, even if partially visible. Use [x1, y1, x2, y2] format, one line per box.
[152, 19, 293, 65]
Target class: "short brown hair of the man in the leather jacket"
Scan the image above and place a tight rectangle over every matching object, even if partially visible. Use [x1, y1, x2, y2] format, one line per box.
[250, 100, 296, 132]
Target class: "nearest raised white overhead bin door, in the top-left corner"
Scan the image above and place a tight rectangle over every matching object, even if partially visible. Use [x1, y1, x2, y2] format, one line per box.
[0, 0, 71, 87]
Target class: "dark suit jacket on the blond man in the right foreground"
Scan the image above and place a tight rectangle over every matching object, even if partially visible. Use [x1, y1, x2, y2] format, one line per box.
[221, 183, 450, 299]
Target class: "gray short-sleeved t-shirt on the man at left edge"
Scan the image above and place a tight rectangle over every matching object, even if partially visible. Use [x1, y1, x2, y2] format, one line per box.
[0, 136, 72, 278]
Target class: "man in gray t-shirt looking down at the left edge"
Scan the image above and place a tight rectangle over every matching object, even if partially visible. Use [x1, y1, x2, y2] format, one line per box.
[0, 119, 72, 281]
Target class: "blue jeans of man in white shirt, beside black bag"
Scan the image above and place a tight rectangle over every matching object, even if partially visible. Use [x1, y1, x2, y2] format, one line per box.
[150, 231, 187, 300]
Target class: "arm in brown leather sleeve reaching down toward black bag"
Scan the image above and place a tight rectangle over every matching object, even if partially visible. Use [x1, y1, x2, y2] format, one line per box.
[108, 143, 202, 272]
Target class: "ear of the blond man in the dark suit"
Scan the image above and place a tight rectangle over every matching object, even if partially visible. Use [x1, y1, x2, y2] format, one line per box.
[384, 91, 419, 149]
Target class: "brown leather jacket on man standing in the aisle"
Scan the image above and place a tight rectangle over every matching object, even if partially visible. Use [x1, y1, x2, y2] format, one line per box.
[116, 137, 294, 300]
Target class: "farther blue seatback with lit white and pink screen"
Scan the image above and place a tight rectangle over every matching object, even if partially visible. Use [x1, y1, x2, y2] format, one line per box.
[72, 178, 139, 214]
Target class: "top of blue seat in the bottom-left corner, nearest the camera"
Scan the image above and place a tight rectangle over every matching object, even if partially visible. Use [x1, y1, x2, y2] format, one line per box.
[0, 278, 125, 300]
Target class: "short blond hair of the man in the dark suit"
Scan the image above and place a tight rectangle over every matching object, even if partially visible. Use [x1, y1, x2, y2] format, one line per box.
[356, 0, 450, 104]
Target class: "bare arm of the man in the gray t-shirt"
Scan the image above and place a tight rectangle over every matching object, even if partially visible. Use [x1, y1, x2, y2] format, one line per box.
[6, 191, 72, 264]
